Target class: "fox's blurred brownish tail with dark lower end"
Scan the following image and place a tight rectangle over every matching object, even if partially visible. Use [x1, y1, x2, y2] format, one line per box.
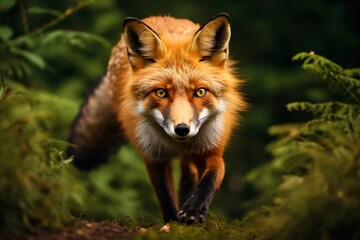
[67, 77, 125, 170]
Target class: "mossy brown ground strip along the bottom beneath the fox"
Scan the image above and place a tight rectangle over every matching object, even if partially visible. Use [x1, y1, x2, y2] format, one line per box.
[0, 217, 262, 240]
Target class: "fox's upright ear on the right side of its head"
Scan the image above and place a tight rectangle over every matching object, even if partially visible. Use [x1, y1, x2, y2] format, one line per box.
[190, 13, 231, 65]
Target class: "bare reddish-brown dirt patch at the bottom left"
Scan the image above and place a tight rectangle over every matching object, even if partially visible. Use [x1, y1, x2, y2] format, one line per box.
[0, 219, 136, 240]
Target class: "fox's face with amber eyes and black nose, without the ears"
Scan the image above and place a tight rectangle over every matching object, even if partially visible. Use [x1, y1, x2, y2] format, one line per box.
[135, 62, 225, 142]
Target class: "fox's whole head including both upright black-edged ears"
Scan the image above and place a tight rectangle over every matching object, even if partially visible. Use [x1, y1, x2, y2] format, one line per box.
[124, 14, 237, 142]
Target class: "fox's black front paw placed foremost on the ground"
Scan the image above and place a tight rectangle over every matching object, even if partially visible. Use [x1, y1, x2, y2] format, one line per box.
[178, 196, 209, 224]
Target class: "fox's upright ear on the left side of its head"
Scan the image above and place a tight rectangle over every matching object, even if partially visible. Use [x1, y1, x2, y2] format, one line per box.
[124, 18, 163, 69]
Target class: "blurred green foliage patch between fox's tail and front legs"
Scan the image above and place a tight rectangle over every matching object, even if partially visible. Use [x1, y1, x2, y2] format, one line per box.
[78, 146, 162, 222]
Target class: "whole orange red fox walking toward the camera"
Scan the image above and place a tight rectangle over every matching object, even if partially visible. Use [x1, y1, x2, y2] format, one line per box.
[70, 13, 246, 224]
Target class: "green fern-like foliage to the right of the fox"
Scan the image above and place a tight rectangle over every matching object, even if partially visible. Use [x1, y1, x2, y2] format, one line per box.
[248, 53, 360, 239]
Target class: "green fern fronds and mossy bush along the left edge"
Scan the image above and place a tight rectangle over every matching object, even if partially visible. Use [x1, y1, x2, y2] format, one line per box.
[0, 0, 111, 233]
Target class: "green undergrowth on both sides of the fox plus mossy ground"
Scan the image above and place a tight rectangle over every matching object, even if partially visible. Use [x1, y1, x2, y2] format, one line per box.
[0, 1, 360, 240]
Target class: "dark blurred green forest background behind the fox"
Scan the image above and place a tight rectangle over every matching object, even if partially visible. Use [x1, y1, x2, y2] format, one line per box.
[0, 0, 360, 223]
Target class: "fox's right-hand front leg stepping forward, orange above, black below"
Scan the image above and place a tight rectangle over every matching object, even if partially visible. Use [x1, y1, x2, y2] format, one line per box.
[178, 156, 225, 224]
